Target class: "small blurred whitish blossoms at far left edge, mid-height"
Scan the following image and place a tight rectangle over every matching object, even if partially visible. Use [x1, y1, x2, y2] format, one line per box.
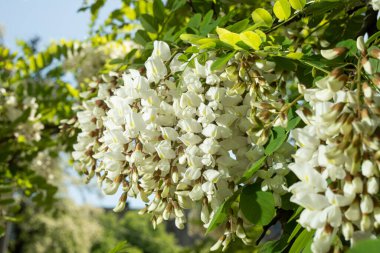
[0, 88, 44, 142]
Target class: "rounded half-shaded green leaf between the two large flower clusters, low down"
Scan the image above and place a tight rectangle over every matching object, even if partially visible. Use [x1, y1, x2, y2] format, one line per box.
[239, 183, 276, 226]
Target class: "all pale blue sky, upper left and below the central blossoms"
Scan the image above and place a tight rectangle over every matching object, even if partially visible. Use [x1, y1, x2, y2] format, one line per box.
[0, 0, 143, 208]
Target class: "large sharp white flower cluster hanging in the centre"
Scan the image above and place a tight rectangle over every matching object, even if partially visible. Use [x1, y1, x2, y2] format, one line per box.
[73, 41, 258, 238]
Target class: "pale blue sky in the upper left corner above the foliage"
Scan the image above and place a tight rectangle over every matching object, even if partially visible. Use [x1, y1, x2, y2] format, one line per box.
[0, 0, 120, 49]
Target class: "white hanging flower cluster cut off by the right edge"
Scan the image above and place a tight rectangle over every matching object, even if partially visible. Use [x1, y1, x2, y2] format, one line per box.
[289, 38, 380, 253]
